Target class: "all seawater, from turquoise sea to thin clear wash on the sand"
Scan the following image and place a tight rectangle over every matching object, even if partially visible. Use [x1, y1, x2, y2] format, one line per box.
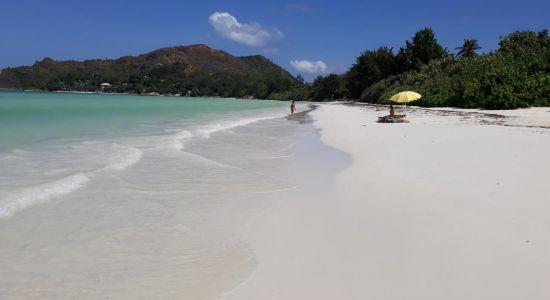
[0, 93, 348, 299]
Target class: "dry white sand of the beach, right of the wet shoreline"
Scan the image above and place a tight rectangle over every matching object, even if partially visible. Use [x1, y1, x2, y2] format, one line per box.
[222, 105, 550, 300]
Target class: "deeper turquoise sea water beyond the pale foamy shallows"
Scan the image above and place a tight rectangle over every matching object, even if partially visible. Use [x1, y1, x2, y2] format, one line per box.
[0, 92, 286, 151]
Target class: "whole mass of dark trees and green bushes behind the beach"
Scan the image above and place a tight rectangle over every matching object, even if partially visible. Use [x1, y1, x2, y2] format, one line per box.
[286, 28, 550, 109]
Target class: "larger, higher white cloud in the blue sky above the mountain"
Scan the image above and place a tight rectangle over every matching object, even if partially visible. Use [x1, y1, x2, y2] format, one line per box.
[208, 12, 283, 47]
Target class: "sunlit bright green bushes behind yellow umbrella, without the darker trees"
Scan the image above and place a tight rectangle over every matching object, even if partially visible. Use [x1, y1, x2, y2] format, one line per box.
[361, 31, 550, 109]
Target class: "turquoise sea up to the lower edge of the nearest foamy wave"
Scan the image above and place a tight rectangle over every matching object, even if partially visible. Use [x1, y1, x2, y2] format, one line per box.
[0, 92, 286, 218]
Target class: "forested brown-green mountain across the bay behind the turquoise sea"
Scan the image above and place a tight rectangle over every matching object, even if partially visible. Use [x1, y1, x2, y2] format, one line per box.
[0, 44, 297, 98]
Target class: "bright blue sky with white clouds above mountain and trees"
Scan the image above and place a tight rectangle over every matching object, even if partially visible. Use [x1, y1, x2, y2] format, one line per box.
[0, 0, 550, 79]
